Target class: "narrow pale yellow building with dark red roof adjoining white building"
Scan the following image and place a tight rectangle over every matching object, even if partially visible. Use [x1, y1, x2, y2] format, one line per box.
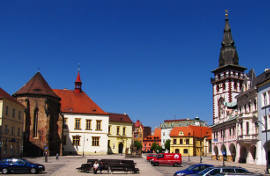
[108, 113, 133, 154]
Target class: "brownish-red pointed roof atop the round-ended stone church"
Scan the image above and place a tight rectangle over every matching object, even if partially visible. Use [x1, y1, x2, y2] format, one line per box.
[14, 72, 59, 98]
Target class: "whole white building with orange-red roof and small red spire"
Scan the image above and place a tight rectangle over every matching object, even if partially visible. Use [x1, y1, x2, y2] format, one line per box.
[53, 72, 109, 155]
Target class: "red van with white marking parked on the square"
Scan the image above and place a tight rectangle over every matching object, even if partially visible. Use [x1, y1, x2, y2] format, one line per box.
[151, 153, 182, 166]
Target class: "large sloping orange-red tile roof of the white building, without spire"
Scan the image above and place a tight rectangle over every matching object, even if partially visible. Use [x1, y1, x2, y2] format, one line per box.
[53, 89, 107, 115]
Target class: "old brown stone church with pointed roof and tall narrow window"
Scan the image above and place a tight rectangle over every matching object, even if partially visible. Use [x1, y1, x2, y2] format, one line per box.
[13, 72, 63, 156]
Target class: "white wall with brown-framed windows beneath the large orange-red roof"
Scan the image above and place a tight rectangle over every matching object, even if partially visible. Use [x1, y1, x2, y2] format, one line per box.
[63, 113, 109, 155]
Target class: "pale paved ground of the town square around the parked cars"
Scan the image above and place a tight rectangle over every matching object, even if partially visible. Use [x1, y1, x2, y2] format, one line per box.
[2, 155, 265, 176]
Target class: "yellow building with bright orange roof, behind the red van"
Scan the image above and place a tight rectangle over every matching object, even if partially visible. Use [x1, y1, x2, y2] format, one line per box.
[170, 126, 211, 156]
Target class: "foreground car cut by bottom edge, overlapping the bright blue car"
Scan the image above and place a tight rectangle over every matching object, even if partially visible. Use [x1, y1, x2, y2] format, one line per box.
[191, 166, 250, 176]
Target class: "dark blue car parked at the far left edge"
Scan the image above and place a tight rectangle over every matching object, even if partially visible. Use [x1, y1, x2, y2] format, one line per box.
[0, 158, 45, 174]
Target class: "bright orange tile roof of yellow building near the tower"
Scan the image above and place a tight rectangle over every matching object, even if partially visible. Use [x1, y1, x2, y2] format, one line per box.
[170, 125, 212, 139]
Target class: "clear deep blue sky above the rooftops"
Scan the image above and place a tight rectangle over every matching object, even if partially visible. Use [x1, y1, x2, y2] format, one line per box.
[0, 0, 270, 127]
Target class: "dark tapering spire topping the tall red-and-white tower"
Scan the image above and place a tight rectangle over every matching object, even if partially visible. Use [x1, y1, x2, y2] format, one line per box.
[219, 10, 239, 67]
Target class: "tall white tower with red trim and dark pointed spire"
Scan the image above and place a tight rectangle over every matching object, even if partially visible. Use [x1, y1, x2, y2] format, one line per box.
[211, 12, 246, 124]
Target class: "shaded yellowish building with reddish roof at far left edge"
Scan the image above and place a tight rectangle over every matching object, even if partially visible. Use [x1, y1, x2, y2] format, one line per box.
[0, 88, 25, 158]
